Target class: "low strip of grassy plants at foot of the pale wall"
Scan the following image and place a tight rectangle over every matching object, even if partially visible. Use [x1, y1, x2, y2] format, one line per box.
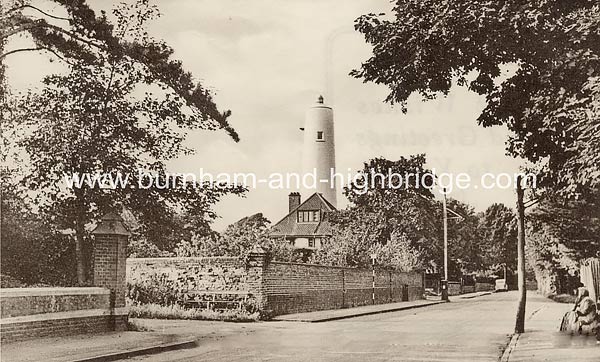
[129, 304, 259, 322]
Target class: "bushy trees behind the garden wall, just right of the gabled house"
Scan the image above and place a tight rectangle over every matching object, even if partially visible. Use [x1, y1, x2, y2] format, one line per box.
[312, 155, 484, 278]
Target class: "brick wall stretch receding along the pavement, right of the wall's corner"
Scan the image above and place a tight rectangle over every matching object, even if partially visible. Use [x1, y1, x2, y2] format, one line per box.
[262, 261, 424, 315]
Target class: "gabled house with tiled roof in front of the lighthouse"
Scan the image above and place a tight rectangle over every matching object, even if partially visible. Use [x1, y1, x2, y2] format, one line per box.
[269, 192, 336, 250]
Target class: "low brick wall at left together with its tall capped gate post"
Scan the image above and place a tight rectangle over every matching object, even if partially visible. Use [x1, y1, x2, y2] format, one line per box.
[0, 213, 129, 342]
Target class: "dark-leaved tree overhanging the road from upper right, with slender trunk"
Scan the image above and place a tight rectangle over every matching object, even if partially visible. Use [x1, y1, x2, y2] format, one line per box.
[351, 0, 600, 333]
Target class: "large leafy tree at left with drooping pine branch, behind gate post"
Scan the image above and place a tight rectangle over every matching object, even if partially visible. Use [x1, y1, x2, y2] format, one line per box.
[0, 0, 243, 284]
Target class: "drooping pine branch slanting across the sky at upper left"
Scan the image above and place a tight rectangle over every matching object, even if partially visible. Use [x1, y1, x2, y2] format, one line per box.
[0, 0, 239, 141]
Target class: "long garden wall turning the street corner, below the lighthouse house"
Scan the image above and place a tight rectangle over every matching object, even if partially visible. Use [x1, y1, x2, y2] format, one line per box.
[126, 249, 424, 315]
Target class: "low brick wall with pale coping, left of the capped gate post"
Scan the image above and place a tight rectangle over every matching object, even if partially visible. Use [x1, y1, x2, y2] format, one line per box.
[0, 288, 114, 342]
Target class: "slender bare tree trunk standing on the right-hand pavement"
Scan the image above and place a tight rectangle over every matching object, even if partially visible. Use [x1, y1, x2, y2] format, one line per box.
[515, 176, 527, 333]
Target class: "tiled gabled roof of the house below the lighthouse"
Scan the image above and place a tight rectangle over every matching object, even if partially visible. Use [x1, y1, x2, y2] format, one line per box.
[270, 192, 336, 237]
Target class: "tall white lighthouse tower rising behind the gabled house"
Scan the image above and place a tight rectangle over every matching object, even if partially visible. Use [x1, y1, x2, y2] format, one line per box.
[302, 96, 337, 207]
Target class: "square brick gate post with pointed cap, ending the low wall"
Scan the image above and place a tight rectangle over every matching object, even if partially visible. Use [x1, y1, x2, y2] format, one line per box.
[92, 213, 130, 331]
